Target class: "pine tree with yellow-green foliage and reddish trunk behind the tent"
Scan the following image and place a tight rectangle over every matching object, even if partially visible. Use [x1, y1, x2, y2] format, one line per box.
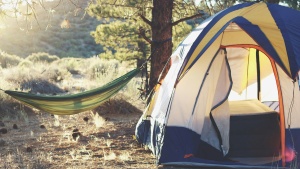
[88, 0, 203, 92]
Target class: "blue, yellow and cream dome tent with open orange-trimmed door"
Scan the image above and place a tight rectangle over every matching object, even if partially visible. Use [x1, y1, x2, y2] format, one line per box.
[136, 2, 300, 168]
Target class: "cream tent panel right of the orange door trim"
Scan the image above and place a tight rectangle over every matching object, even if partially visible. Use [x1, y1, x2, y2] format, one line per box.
[276, 65, 300, 128]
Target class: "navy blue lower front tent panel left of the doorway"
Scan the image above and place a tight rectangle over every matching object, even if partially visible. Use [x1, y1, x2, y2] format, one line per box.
[159, 127, 237, 164]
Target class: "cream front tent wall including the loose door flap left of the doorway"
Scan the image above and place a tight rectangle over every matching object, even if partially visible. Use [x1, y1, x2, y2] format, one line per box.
[167, 35, 230, 152]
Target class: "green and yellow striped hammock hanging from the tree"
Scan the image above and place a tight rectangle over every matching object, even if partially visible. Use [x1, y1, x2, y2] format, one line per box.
[5, 69, 140, 115]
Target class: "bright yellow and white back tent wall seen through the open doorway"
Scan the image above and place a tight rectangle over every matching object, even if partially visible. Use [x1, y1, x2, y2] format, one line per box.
[227, 48, 278, 101]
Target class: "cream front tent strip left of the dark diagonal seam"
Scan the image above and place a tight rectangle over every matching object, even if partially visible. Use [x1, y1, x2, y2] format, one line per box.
[167, 34, 221, 131]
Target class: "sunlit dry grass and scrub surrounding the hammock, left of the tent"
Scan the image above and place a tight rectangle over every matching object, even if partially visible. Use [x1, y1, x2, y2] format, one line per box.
[0, 58, 156, 169]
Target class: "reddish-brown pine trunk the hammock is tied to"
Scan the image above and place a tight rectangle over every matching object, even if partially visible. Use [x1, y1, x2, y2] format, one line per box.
[149, 0, 173, 89]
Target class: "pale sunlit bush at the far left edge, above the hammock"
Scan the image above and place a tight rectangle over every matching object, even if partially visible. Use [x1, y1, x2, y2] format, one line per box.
[0, 51, 23, 68]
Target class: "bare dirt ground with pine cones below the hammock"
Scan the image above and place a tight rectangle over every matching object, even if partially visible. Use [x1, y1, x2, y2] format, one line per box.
[0, 98, 157, 169]
